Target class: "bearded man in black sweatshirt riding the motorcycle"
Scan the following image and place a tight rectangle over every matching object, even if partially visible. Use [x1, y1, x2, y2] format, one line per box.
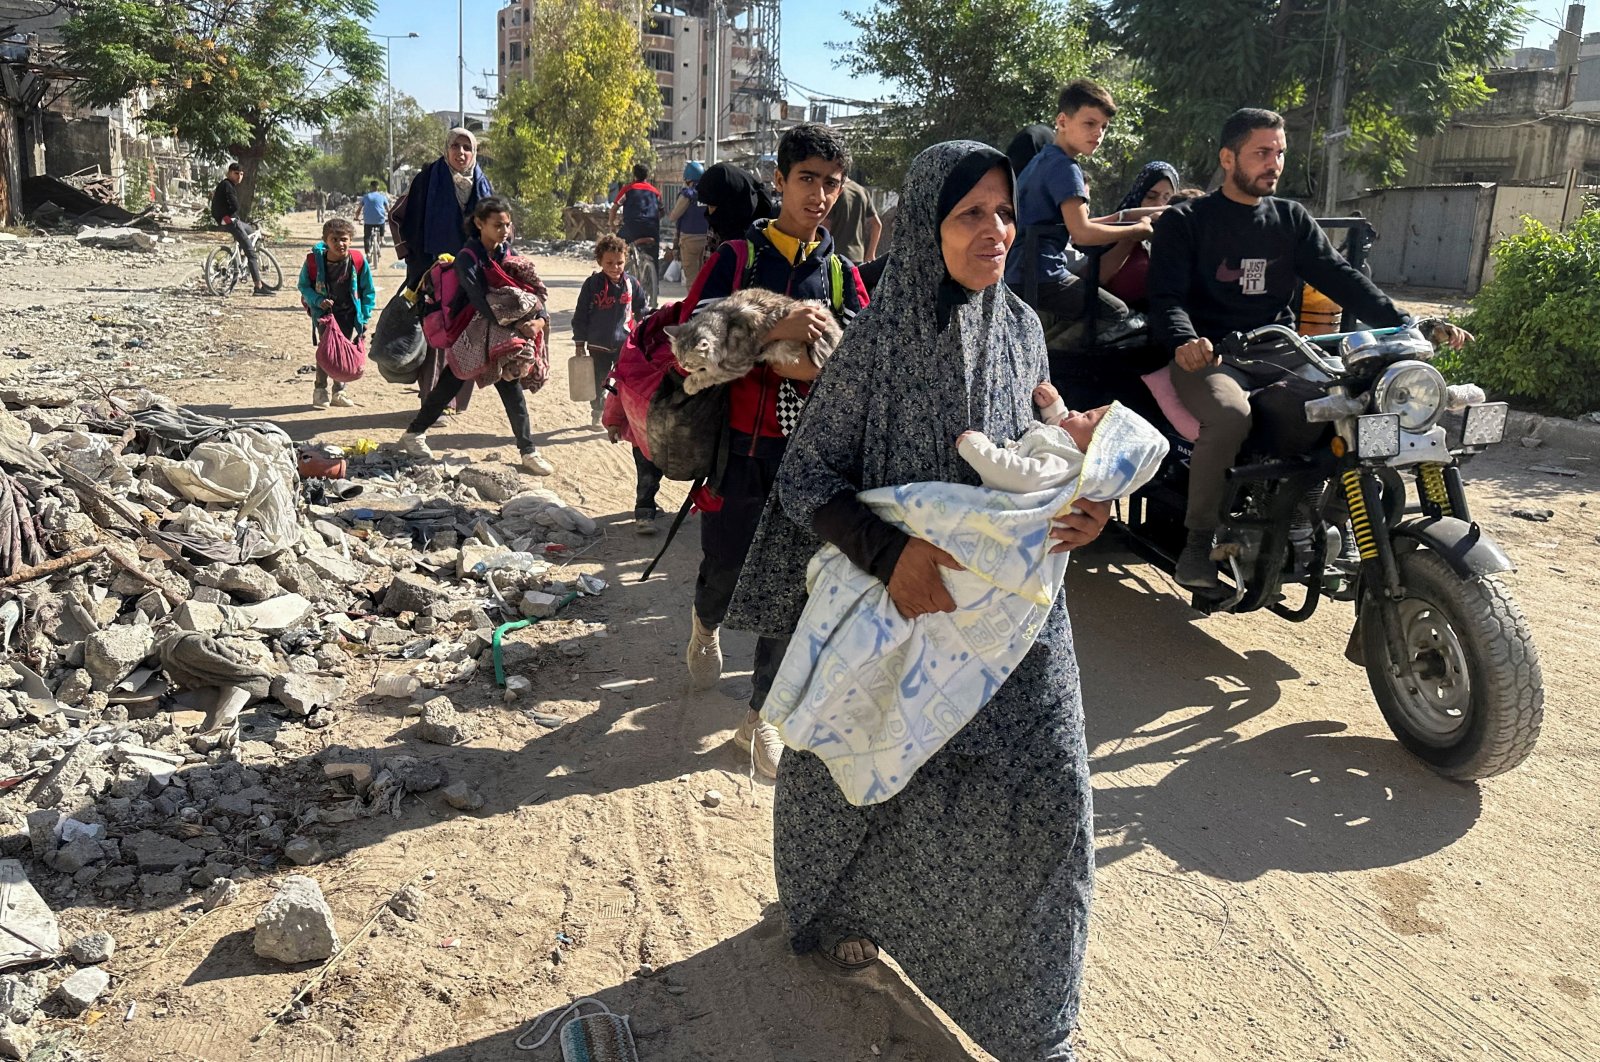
[1149, 107, 1470, 592]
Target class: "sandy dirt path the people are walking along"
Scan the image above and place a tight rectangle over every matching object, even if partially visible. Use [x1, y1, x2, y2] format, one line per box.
[0, 218, 1600, 1062]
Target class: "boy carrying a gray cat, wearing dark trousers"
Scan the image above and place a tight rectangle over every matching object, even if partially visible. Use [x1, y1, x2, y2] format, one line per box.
[686, 123, 867, 777]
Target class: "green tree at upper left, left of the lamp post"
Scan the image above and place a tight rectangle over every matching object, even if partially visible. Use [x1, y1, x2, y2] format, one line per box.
[62, 0, 384, 216]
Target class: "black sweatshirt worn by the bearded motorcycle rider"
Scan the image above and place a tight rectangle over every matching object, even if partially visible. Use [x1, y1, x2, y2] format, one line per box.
[1147, 192, 1402, 352]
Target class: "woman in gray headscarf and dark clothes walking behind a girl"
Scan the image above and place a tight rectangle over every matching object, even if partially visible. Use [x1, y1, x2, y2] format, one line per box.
[400, 126, 494, 413]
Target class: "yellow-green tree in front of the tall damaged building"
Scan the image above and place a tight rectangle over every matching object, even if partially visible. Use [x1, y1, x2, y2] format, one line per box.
[483, 0, 661, 237]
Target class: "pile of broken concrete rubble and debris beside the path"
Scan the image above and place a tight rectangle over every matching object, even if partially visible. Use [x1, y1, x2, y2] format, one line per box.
[0, 385, 605, 1057]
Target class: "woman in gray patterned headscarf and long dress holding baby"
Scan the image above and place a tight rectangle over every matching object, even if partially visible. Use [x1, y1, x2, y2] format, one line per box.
[726, 141, 1109, 1062]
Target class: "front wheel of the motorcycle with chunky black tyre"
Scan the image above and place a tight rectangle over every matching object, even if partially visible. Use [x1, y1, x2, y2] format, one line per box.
[1362, 549, 1544, 781]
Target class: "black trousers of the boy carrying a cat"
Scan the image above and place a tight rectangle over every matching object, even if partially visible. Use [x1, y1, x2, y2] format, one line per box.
[694, 446, 789, 712]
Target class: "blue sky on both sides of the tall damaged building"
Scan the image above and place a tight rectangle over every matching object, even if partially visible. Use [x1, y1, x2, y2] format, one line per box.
[371, 0, 886, 110]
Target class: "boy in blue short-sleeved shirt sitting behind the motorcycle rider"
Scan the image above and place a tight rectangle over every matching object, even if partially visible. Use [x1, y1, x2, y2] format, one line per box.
[1005, 80, 1158, 342]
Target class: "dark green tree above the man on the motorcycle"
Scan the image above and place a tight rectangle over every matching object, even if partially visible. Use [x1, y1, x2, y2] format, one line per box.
[1107, 0, 1523, 194]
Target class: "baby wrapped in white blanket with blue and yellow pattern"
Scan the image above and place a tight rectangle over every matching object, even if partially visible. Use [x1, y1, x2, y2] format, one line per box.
[762, 384, 1166, 806]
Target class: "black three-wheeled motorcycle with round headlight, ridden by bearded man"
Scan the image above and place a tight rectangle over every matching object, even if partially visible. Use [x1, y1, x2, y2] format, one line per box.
[1058, 325, 1544, 781]
